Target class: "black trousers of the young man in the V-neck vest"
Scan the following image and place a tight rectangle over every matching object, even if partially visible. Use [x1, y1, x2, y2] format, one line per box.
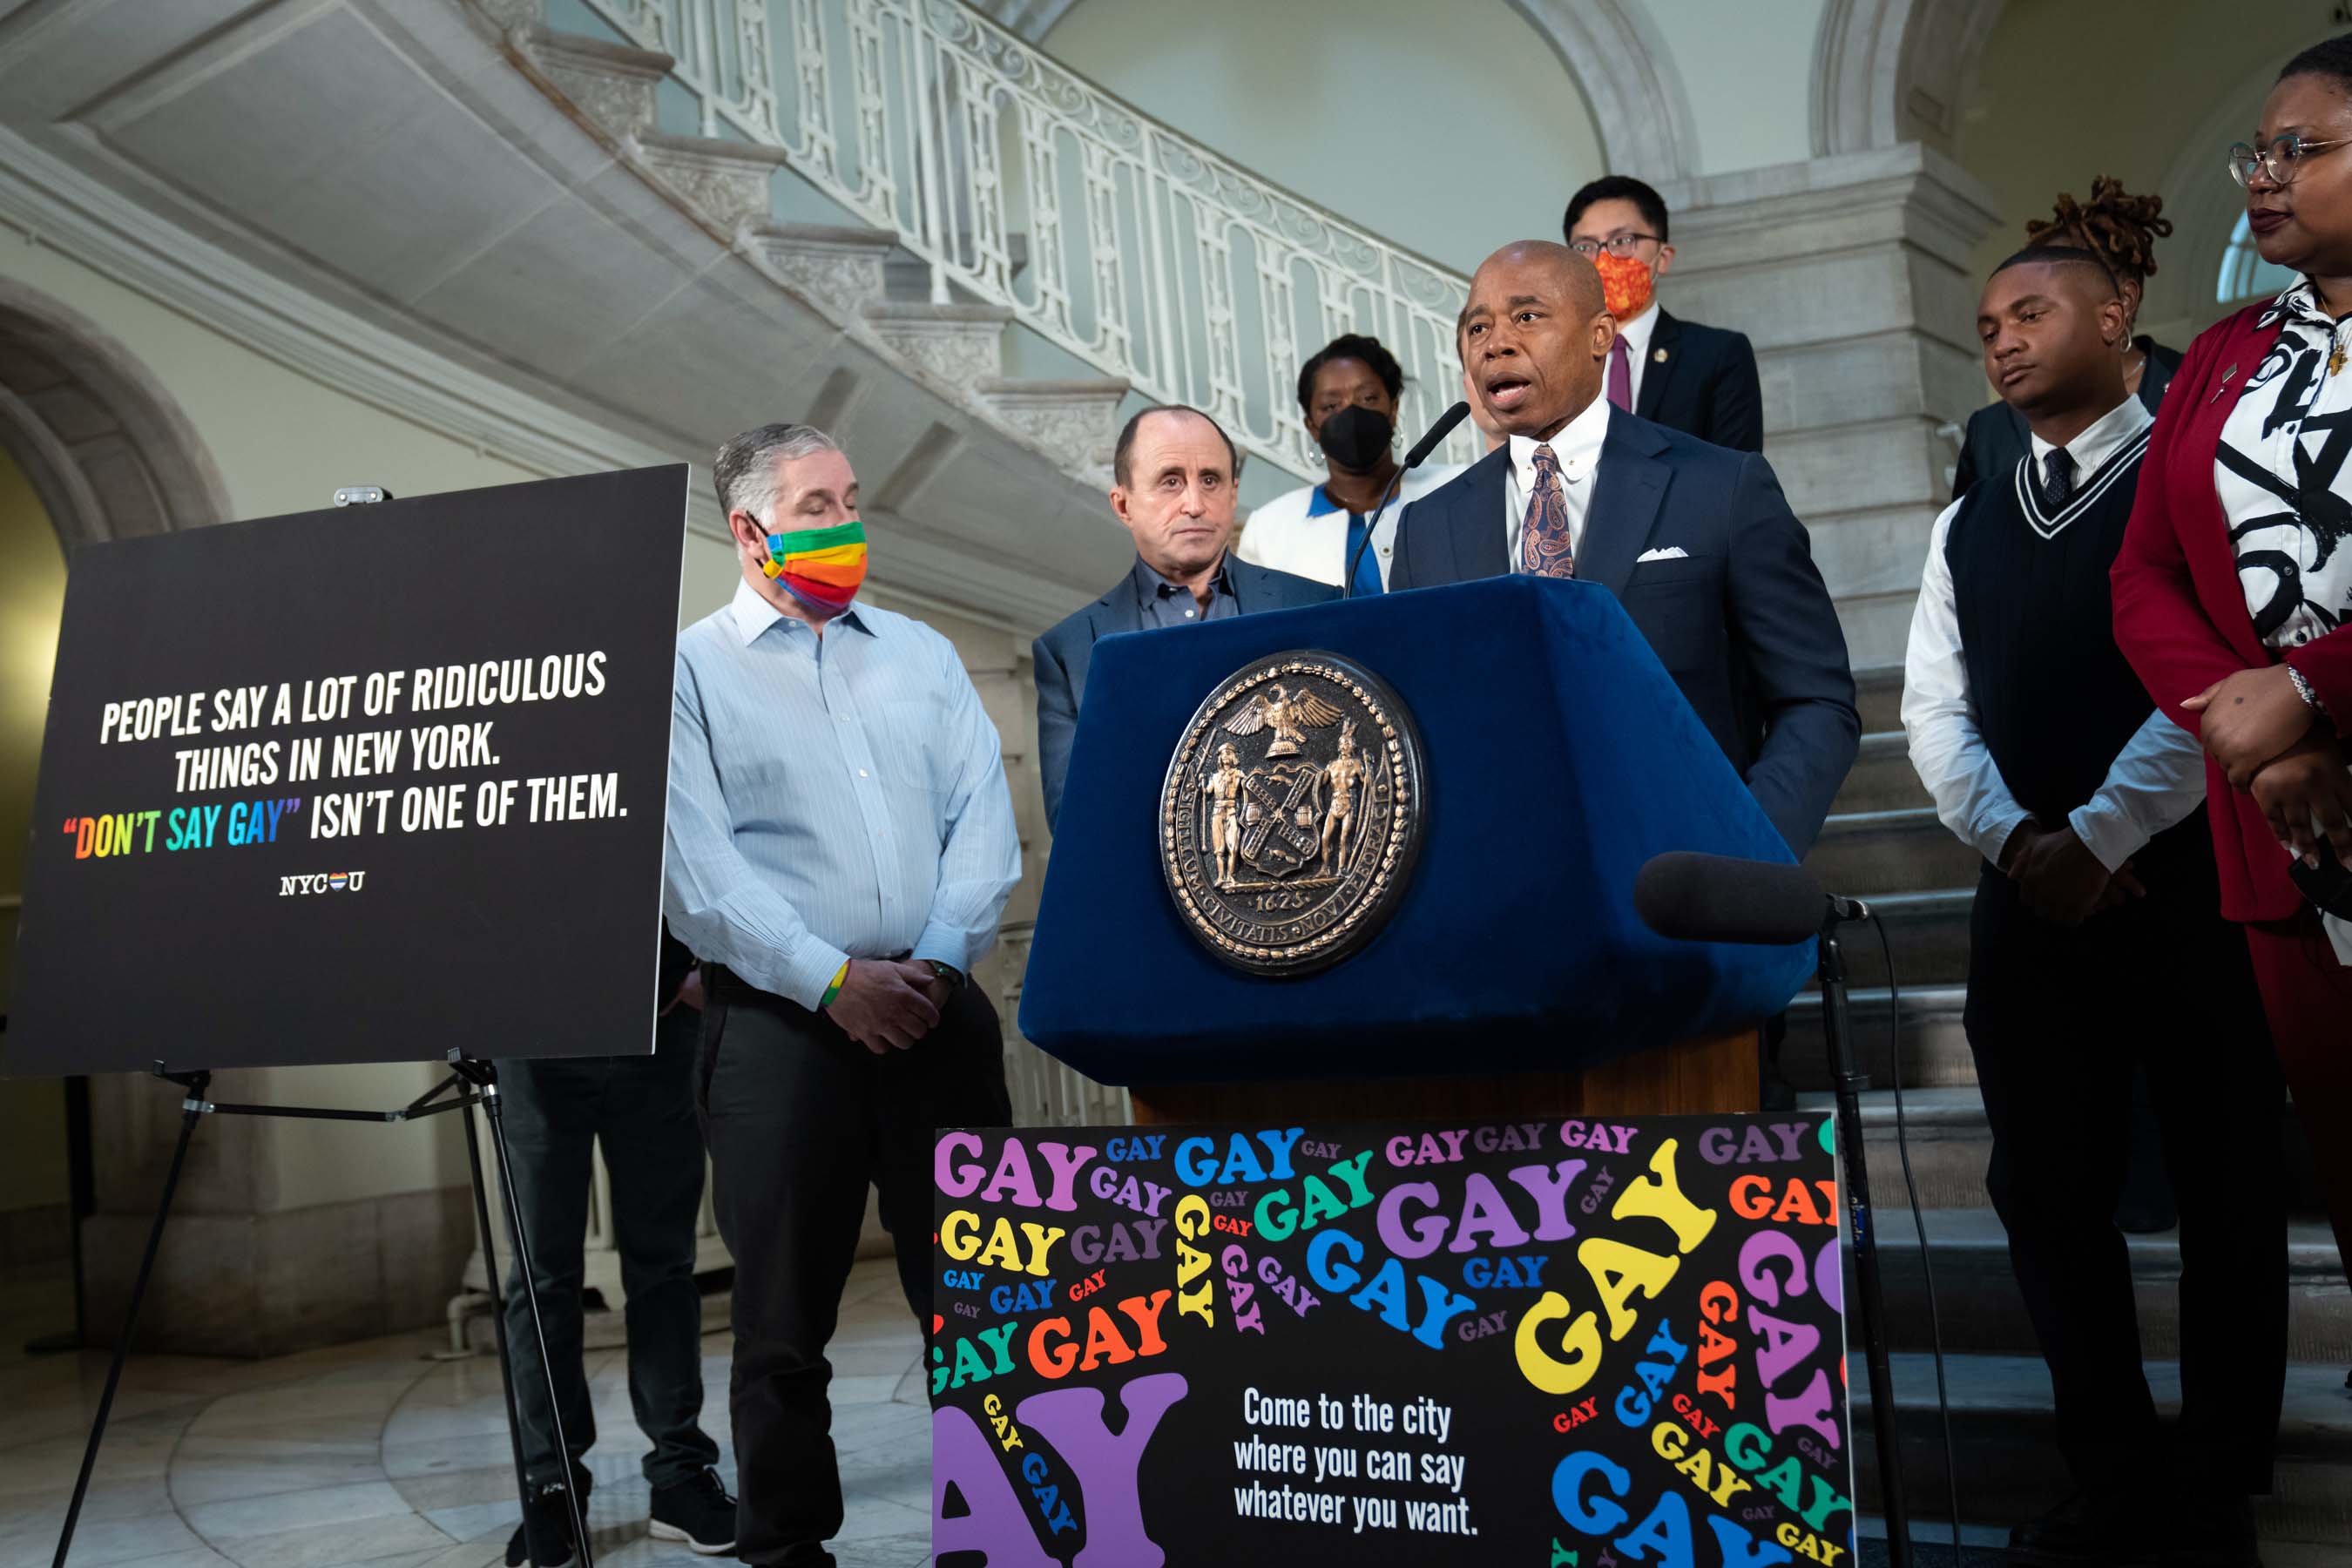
[1966, 860, 2286, 1493]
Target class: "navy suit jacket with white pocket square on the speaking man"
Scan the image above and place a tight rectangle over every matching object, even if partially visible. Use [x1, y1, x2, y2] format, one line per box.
[1388, 411, 1862, 855]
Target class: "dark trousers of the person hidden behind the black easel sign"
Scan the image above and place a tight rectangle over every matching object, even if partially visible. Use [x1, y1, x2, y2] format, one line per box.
[498, 1006, 720, 1495]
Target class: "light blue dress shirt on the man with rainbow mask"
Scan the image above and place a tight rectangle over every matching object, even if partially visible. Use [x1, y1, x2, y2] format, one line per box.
[663, 583, 1021, 1009]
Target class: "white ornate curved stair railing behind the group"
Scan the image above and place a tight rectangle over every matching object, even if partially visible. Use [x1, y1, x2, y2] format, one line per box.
[578, 0, 1477, 475]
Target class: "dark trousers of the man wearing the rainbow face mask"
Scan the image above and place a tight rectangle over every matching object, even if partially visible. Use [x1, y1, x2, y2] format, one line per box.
[703, 966, 1011, 1564]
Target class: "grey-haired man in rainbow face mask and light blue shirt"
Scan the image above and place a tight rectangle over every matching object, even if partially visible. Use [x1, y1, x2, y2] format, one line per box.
[663, 425, 1021, 1568]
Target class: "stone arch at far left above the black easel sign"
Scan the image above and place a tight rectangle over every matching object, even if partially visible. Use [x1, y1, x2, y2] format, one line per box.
[0, 277, 228, 555]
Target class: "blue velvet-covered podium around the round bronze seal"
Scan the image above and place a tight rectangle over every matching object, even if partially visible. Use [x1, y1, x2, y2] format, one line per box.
[1021, 576, 1814, 1121]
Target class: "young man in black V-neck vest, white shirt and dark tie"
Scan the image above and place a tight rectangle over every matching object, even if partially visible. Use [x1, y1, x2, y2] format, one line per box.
[1903, 247, 2286, 1568]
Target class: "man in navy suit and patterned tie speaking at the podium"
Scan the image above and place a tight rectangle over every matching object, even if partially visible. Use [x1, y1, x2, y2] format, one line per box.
[1388, 240, 1861, 855]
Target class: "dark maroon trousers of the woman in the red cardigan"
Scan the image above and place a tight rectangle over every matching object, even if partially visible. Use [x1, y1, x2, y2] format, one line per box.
[2247, 909, 2352, 1258]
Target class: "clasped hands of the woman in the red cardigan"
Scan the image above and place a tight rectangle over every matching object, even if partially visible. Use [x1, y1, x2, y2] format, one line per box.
[2180, 666, 2352, 865]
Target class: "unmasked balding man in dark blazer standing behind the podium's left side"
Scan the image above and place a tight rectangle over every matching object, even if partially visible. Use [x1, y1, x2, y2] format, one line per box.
[1031, 404, 1338, 828]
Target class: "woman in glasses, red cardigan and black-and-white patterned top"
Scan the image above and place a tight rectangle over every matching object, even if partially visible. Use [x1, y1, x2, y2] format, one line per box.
[2114, 35, 2352, 1258]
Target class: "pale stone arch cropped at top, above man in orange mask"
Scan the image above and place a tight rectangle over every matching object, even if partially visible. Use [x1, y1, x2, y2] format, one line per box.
[978, 0, 1698, 180]
